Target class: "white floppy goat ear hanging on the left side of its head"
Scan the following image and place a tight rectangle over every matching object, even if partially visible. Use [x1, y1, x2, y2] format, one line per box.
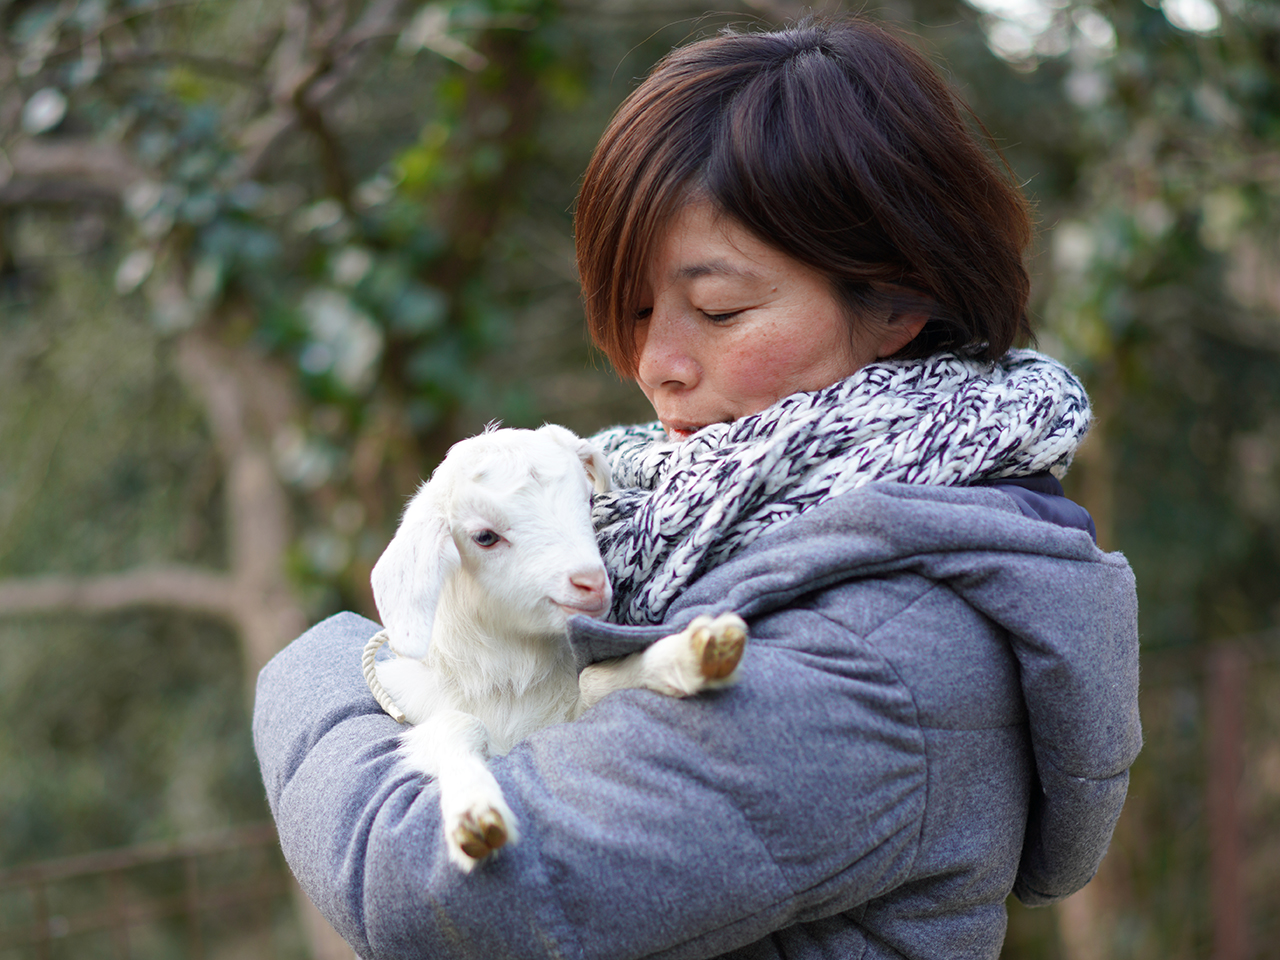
[371, 486, 462, 659]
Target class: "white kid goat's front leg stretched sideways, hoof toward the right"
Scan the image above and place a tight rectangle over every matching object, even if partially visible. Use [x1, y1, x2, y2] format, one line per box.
[577, 613, 746, 712]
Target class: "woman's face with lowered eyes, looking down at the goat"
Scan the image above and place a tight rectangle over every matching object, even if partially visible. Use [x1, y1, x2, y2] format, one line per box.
[635, 201, 924, 440]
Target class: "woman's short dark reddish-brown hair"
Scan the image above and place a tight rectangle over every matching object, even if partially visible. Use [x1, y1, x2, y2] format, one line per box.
[573, 18, 1032, 376]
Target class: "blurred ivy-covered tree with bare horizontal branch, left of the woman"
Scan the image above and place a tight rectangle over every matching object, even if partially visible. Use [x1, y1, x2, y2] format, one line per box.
[4, 0, 586, 668]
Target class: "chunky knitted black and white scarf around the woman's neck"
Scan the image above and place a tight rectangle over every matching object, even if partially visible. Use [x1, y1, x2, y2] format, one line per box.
[593, 349, 1089, 623]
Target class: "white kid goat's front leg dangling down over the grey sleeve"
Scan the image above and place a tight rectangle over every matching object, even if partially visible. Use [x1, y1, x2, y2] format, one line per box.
[401, 709, 520, 873]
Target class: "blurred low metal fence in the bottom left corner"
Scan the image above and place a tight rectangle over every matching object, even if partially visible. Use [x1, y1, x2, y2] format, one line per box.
[0, 823, 305, 960]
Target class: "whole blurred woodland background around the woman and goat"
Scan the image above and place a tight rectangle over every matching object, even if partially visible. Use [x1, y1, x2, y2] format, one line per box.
[0, 0, 1280, 960]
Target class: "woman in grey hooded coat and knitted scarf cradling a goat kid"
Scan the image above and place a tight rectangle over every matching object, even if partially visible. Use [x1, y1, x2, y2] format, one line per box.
[255, 19, 1140, 960]
